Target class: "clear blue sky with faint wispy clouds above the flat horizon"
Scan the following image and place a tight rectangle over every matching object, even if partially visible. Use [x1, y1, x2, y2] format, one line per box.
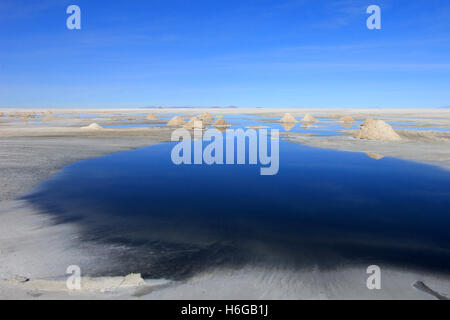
[0, 0, 450, 108]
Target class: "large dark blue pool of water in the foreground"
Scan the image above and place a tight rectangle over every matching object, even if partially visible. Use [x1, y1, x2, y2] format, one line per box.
[25, 141, 450, 279]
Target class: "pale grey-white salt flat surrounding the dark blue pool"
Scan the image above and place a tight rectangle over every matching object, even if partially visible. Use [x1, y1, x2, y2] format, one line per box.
[0, 108, 450, 299]
